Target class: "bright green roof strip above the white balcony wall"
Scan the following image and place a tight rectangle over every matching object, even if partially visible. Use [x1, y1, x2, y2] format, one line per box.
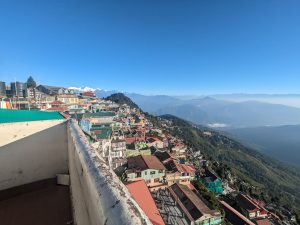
[0, 109, 64, 123]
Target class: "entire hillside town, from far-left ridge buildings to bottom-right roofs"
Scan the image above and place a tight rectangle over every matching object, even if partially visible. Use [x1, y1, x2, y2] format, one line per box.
[0, 78, 297, 225]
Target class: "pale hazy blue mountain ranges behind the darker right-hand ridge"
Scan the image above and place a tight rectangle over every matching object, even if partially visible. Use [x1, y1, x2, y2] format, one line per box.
[90, 89, 300, 128]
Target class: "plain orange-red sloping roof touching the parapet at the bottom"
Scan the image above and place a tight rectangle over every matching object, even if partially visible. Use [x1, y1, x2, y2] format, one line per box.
[126, 180, 165, 225]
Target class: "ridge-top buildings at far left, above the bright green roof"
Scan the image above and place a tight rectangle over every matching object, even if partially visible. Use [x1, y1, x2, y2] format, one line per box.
[0, 81, 95, 114]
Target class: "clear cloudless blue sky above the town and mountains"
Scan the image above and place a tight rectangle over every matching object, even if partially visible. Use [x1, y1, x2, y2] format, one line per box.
[0, 0, 300, 94]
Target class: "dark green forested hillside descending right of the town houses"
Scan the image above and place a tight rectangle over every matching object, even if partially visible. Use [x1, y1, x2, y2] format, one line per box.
[108, 94, 300, 213]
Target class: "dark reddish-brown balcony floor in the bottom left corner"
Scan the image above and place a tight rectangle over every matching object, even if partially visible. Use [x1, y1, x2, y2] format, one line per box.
[0, 179, 73, 225]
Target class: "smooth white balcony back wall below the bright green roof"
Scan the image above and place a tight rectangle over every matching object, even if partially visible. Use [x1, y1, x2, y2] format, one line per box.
[0, 120, 68, 190]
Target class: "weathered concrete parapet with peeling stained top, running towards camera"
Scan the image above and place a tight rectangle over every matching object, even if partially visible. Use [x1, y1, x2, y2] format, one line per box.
[68, 121, 151, 225]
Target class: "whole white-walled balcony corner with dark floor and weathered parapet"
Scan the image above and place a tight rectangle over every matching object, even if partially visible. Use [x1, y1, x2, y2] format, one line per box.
[0, 119, 151, 225]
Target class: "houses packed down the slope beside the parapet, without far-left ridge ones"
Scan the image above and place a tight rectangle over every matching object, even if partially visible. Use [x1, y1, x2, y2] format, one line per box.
[59, 89, 282, 225]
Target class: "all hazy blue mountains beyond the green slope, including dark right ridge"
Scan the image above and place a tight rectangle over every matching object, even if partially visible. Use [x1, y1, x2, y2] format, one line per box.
[96, 90, 300, 169]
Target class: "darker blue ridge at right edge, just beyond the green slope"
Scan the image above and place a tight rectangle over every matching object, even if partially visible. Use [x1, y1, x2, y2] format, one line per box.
[225, 125, 300, 168]
